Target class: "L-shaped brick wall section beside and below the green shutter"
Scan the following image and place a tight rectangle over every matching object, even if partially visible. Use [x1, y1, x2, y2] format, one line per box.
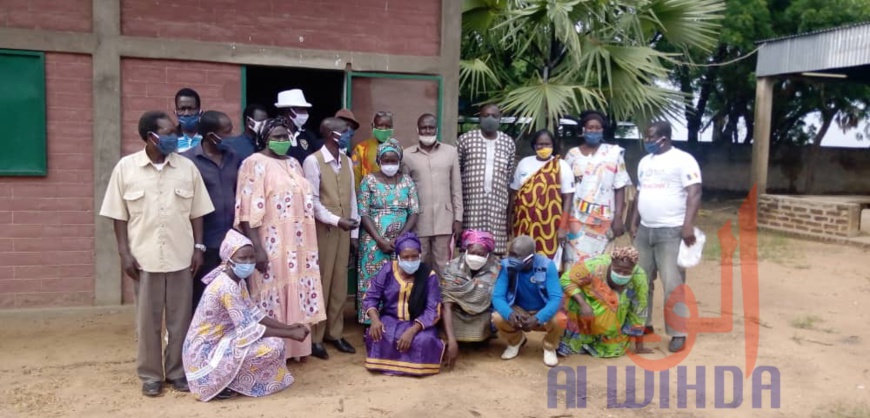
[0, 53, 94, 308]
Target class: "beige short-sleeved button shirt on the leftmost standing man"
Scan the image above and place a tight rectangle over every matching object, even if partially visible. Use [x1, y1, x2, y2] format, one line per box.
[100, 149, 214, 273]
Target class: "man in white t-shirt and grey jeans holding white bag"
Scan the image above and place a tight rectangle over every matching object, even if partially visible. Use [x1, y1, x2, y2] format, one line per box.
[630, 122, 701, 352]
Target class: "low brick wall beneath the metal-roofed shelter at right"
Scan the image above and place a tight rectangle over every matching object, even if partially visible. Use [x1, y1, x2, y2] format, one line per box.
[758, 195, 861, 237]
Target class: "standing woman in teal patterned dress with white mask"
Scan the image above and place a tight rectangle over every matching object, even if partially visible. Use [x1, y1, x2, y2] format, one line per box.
[357, 139, 420, 324]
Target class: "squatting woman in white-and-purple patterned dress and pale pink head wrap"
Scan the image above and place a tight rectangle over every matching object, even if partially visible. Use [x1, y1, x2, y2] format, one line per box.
[183, 230, 308, 402]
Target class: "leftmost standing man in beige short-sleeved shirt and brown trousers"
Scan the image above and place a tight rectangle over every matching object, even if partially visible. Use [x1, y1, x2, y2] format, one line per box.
[100, 112, 214, 396]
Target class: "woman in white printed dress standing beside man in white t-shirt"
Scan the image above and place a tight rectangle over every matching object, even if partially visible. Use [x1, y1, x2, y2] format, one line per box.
[560, 111, 631, 266]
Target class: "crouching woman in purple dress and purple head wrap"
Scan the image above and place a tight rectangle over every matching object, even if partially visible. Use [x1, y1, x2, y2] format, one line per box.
[362, 232, 444, 376]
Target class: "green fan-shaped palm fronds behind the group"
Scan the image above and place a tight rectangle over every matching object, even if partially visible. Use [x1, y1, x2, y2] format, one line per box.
[460, 0, 724, 130]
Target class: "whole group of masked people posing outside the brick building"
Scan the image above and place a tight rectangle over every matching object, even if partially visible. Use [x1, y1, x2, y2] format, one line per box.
[100, 88, 701, 401]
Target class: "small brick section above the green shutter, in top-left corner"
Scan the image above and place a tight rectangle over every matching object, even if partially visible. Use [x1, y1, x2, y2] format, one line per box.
[0, 0, 92, 32]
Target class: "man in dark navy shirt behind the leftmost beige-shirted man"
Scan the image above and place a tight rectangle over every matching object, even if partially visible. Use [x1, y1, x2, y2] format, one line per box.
[181, 110, 242, 312]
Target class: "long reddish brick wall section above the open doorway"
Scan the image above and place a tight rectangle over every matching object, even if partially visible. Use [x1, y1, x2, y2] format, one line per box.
[121, 0, 440, 56]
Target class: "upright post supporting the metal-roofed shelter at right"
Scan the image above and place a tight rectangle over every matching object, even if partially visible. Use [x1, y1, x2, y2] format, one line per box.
[749, 77, 773, 195]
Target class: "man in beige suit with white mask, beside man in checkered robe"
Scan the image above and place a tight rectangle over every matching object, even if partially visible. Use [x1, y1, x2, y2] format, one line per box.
[402, 113, 462, 276]
